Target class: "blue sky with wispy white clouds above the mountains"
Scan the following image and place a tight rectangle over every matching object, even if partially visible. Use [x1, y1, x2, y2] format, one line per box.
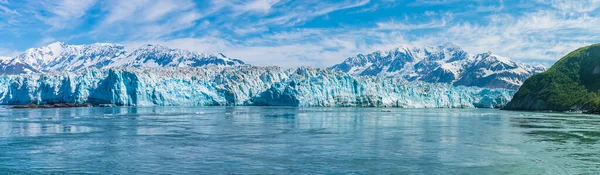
[0, 0, 600, 67]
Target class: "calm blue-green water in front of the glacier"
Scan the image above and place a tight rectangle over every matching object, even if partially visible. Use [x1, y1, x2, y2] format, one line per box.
[0, 107, 600, 174]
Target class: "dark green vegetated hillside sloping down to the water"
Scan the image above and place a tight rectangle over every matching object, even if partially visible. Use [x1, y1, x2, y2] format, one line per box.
[504, 44, 600, 113]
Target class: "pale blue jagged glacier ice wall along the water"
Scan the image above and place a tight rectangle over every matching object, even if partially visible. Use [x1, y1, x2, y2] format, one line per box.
[0, 65, 514, 108]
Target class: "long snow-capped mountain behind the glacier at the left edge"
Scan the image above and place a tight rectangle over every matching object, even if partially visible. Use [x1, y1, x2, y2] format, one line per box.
[0, 42, 244, 74]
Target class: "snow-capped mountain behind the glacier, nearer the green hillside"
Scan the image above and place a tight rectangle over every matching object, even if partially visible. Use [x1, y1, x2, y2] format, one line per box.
[329, 44, 546, 89]
